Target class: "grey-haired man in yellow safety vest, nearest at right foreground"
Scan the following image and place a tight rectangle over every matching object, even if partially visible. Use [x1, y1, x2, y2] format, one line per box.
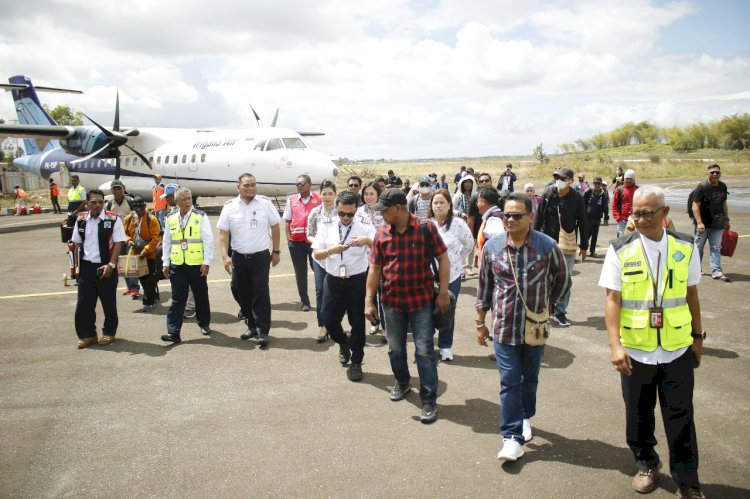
[599, 185, 706, 498]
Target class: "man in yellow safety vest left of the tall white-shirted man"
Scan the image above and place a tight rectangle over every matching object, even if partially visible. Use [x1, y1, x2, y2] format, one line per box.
[161, 187, 214, 343]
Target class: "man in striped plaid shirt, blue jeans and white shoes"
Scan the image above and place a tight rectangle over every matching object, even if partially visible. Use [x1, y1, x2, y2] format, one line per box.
[476, 192, 571, 461]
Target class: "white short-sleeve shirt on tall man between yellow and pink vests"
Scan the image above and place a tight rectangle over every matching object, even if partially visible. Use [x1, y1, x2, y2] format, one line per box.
[216, 196, 281, 254]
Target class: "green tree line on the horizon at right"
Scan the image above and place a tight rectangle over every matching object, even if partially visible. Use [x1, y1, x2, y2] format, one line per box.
[558, 113, 750, 153]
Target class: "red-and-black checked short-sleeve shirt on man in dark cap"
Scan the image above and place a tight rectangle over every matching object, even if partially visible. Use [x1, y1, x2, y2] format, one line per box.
[370, 213, 447, 312]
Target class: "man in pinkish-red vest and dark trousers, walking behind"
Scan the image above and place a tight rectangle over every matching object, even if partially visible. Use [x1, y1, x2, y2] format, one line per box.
[282, 175, 321, 312]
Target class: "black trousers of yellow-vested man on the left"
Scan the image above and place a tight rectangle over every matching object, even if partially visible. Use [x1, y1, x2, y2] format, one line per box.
[167, 264, 211, 334]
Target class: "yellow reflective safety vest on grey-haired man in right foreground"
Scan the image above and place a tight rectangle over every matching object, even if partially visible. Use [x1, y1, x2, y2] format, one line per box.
[617, 234, 693, 352]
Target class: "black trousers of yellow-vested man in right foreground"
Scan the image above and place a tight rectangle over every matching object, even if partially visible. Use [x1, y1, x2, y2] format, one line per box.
[621, 348, 700, 487]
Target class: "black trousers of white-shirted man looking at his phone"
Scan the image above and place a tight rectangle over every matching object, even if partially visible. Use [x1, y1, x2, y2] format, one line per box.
[323, 272, 367, 363]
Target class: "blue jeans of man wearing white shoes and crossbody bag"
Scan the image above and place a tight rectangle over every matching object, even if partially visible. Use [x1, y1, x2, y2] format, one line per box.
[493, 341, 544, 443]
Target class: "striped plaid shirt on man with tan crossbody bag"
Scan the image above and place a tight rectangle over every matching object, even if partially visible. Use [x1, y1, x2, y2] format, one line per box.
[475, 231, 571, 345]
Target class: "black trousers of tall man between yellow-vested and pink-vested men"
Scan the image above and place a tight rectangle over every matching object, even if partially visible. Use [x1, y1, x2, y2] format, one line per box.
[232, 250, 271, 334]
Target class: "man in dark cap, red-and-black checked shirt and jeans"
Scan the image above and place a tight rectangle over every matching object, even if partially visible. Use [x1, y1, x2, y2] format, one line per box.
[365, 189, 450, 424]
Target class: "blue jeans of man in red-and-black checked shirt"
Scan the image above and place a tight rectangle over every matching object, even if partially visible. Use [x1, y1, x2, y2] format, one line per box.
[383, 306, 438, 404]
